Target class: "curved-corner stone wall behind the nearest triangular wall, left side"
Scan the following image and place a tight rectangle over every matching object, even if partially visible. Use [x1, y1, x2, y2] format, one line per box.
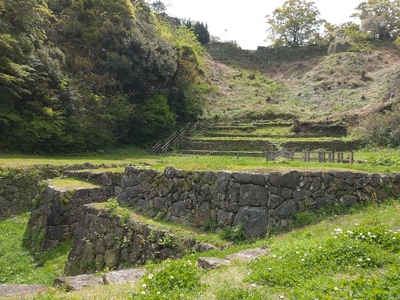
[25, 172, 120, 252]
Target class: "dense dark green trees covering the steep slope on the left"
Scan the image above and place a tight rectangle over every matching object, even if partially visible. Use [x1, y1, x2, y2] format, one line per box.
[0, 0, 203, 153]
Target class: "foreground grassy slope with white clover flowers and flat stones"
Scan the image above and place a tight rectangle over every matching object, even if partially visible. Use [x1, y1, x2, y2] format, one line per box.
[11, 200, 400, 300]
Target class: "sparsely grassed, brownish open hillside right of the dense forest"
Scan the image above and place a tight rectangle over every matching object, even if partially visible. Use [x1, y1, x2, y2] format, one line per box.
[205, 43, 400, 126]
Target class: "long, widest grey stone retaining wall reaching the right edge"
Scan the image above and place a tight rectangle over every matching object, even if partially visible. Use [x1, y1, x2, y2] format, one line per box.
[117, 167, 400, 238]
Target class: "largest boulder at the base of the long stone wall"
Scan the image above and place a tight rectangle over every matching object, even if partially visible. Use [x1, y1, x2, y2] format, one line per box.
[233, 206, 269, 239]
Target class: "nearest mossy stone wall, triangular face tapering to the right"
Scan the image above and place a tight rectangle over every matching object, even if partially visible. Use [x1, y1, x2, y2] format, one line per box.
[64, 205, 200, 275]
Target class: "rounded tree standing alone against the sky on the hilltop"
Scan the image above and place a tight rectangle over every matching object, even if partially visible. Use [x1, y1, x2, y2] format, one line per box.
[266, 0, 325, 48]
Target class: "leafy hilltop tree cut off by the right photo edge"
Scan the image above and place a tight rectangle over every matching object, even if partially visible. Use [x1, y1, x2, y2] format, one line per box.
[352, 0, 400, 40]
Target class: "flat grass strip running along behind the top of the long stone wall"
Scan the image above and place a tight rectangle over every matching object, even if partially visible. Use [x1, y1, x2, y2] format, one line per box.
[0, 149, 400, 173]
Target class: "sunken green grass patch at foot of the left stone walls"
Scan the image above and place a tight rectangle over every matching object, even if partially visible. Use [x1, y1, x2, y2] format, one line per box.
[0, 213, 71, 286]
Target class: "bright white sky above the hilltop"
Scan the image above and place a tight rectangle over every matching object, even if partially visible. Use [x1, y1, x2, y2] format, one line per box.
[164, 0, 362, 50]
